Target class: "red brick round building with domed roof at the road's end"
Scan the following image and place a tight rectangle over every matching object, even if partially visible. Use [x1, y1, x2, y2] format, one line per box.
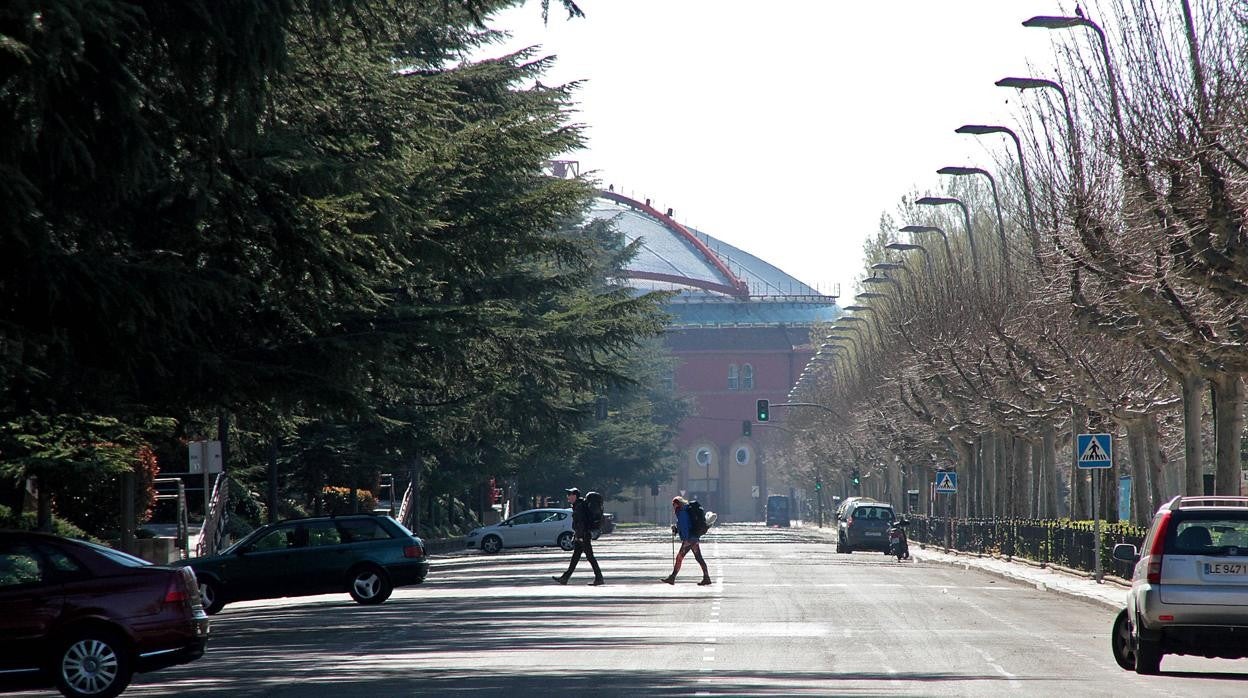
[592, 191, 840, 521]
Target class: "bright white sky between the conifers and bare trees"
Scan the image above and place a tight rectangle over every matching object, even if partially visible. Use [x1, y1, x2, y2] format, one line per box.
[481, 0, 1075, 305]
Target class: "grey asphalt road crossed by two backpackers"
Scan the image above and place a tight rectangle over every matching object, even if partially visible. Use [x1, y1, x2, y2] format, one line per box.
[12, 524, 1248, 698]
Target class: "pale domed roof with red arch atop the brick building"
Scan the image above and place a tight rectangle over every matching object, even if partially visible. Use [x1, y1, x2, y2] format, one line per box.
[590, 191, 841, 327]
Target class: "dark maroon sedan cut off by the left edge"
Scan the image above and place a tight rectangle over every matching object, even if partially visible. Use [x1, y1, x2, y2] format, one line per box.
[0, 531, 208, 698]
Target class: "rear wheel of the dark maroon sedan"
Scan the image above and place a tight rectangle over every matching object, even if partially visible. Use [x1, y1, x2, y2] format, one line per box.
[56, 629, 134, 698]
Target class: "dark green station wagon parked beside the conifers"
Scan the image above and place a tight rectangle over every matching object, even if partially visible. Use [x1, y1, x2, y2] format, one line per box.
[178, 514, 429, 614]
